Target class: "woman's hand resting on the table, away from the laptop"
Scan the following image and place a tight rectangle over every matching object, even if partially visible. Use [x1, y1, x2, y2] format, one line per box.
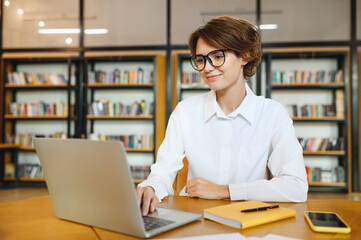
[186, 177, 230, 199]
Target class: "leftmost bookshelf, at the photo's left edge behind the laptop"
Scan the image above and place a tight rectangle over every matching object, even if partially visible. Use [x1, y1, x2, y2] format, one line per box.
[0, 56, 78, 186]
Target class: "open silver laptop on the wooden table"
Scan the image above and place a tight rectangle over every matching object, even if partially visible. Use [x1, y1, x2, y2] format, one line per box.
[34, 138, 202, 238]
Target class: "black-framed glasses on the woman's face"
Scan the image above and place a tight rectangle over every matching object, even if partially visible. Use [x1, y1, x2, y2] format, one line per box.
[190, 49, 230, 71]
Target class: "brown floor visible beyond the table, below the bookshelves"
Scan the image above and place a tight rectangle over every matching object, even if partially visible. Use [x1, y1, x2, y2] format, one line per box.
[0, 187, 361, 203]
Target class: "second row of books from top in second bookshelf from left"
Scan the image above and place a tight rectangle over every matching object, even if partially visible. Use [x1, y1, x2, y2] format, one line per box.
[88, 100, 154, 116]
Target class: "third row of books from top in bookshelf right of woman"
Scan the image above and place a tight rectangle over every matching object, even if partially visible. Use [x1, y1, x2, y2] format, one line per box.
[298, 137, 345, 152]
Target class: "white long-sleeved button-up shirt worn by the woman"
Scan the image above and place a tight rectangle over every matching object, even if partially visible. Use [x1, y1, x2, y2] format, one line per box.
[140, 84, 308, 202]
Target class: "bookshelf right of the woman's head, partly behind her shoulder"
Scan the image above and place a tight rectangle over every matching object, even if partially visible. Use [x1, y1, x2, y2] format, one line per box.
[264, 49, 351, 191]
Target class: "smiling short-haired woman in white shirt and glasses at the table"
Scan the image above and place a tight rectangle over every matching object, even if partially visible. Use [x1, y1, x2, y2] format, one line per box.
[137, 17, 308, 215]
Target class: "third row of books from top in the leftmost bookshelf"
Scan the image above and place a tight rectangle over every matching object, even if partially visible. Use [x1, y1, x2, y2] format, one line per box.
[5, 132, 68, 148]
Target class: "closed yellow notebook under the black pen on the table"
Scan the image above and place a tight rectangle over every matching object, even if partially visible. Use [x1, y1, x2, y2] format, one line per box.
[204, 201, 296, 229]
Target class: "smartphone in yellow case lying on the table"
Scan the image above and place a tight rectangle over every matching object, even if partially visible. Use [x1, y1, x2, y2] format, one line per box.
[304, 211, 351, 233]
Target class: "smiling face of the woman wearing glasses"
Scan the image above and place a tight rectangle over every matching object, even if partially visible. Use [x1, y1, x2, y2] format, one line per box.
[196, 38, 247, 91]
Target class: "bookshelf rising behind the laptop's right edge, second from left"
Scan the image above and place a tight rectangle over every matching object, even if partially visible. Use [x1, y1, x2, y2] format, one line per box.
[83, 55, 166, 183]
